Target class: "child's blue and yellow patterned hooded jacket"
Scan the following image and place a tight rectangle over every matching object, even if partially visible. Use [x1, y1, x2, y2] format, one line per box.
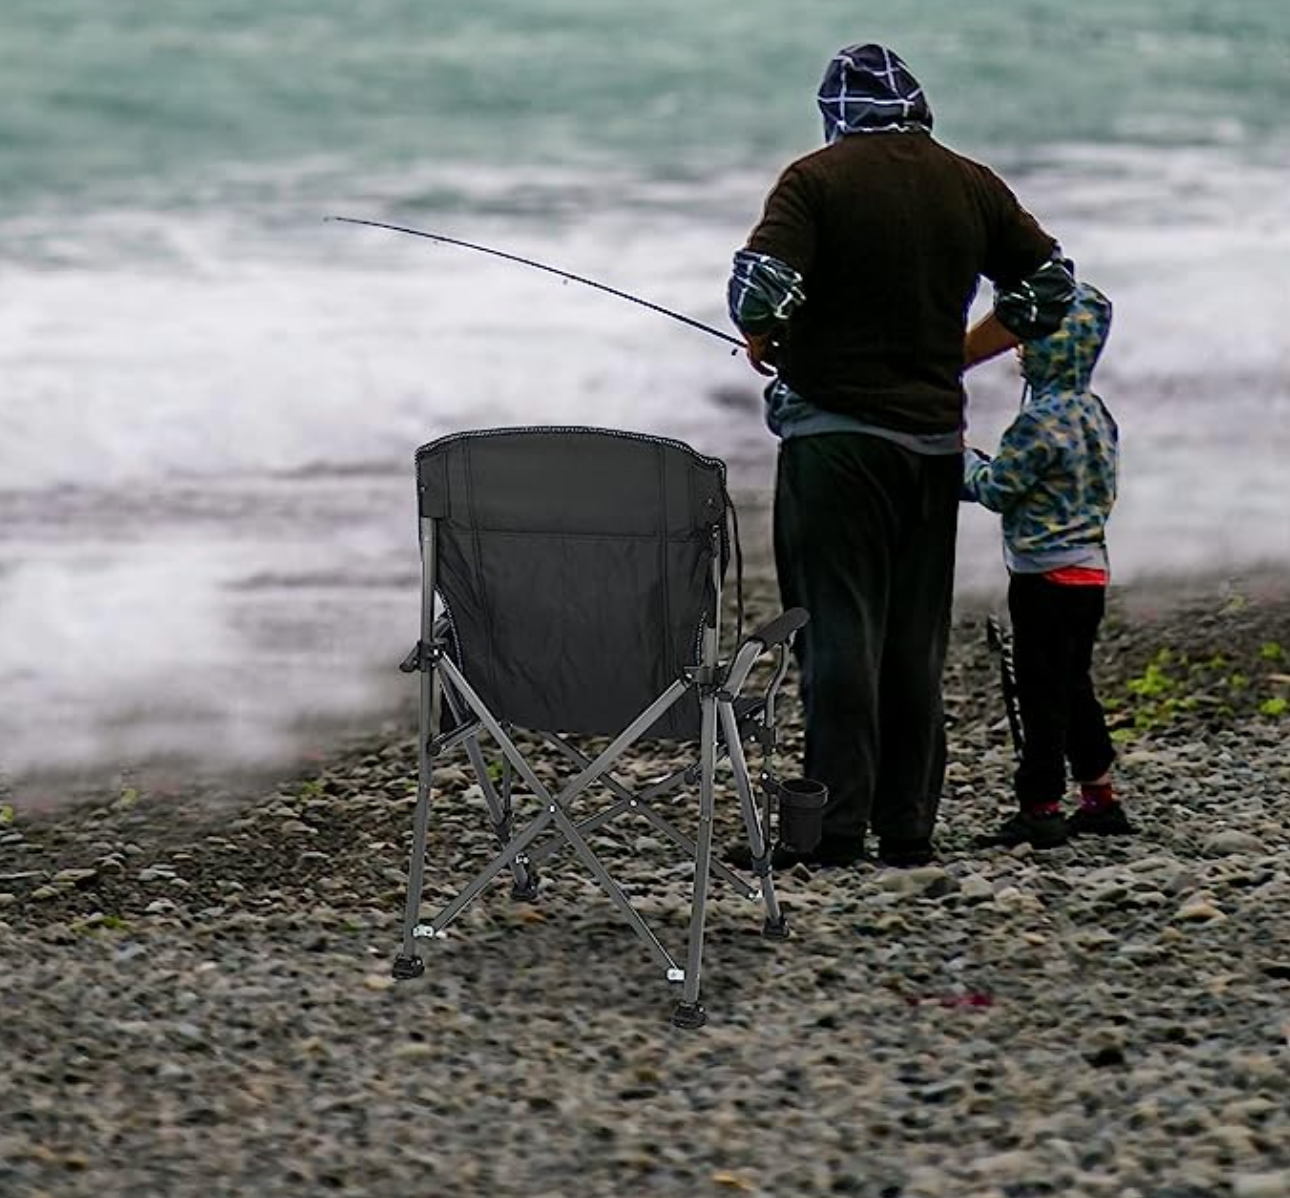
[964, 282, 1120, 574]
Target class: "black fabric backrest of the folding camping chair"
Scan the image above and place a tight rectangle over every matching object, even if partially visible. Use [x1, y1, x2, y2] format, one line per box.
[417, 427, 729, 739]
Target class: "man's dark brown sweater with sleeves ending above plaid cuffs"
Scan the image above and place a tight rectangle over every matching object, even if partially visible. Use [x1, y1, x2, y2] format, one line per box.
[747, 132, 1057, 433]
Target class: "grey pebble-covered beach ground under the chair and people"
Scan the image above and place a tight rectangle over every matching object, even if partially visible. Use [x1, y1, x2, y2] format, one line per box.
[0, 578, 1290, 1198]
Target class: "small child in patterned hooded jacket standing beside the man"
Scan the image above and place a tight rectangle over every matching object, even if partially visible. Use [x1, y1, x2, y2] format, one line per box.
[964, 282, 1134, 849]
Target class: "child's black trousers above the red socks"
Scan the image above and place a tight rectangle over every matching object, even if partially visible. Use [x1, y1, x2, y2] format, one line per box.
[1007, 574, 1116, 809]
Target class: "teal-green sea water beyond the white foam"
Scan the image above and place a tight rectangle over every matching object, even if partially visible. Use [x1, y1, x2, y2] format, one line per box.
[0, 0, 1290, 213]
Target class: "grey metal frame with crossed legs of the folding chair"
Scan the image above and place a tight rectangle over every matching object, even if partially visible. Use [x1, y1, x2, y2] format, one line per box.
[392, 429, 808, 1028]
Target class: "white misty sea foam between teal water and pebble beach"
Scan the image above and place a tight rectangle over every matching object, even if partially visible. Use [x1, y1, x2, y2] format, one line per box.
[0, 140, 1290, 771]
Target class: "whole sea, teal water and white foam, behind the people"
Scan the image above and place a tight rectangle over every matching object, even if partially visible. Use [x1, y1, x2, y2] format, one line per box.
[0, 0, 1290, 780]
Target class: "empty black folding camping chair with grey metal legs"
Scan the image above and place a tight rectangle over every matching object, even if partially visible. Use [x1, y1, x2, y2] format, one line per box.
[393, 427, 823, 1028]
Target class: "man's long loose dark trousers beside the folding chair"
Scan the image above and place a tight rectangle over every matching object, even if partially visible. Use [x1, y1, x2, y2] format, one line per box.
[774, 432, 962, 841]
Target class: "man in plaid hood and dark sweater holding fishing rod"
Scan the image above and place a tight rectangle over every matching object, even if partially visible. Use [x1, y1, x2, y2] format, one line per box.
[729, 45, 1075, 869]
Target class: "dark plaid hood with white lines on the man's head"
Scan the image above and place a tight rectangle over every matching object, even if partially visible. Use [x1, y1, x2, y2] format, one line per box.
[817, 45, 931, 146]
